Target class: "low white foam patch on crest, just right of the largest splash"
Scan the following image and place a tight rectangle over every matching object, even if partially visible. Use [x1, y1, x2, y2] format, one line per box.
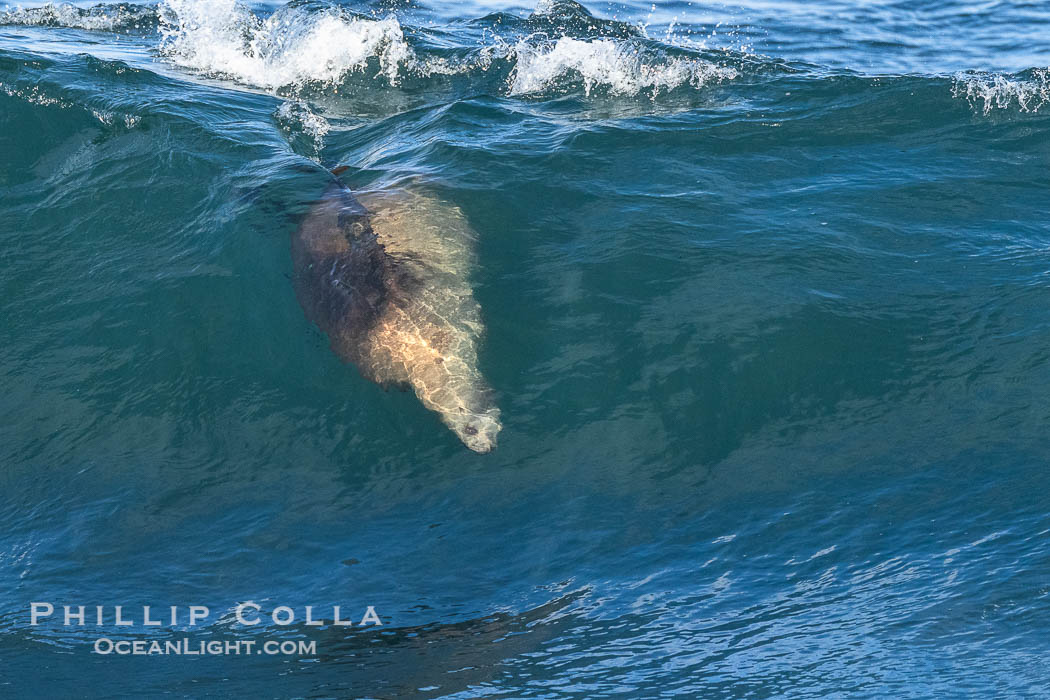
[510, 37, 737, 97]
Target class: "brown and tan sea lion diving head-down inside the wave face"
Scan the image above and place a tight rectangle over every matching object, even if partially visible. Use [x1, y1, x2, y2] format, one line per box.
[292, 168, 503, 452]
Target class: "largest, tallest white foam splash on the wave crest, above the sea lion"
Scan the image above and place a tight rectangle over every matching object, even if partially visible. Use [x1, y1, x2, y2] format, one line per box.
[162, 0, 414, 89]
